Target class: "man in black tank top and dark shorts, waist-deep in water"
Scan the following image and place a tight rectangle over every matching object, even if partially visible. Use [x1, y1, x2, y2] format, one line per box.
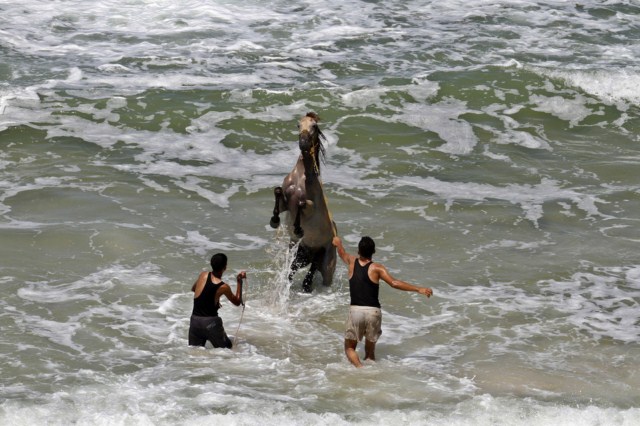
[189, 253, 247, 349]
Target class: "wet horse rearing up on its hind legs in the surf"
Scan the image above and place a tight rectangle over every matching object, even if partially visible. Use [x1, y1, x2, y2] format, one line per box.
[270, 112, 337, 292]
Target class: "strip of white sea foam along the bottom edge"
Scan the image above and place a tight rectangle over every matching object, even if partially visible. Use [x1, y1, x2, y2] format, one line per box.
[2, 382, 640, 426]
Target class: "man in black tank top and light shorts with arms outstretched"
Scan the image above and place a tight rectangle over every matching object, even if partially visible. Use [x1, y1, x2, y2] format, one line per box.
[333, 237, 433, 367]
